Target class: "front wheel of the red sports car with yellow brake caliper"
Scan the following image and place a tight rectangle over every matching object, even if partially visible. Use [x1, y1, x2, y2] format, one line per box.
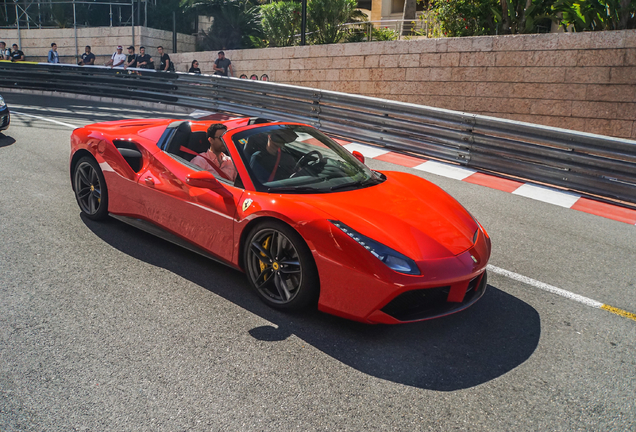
[243, 220, 320, 311]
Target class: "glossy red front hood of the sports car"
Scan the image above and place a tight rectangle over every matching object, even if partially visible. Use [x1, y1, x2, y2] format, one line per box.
[306, 172, 478, 260]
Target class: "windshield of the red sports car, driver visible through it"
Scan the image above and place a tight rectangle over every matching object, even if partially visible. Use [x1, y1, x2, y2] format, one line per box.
[232, 125, 384, 193]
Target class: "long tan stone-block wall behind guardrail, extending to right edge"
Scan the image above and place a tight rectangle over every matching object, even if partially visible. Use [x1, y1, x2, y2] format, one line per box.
[172, 30, 636, 139]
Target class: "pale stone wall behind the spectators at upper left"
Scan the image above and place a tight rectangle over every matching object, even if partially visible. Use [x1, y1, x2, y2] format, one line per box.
[0, 27, 195, 64]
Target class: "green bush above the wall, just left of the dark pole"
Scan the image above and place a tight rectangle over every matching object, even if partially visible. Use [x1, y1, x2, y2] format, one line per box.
[261, 1, 302, 46]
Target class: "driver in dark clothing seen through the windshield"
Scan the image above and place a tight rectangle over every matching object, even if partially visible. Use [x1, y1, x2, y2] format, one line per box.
[250, 129, 297, 183]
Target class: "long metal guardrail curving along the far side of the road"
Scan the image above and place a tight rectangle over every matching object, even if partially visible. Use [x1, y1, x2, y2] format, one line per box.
[0, 62, 636, 206]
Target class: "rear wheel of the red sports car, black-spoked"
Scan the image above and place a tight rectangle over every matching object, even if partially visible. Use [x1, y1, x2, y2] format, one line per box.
[73, 156, 108, 220]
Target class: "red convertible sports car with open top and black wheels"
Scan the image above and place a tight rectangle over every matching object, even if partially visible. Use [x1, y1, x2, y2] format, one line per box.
[70, 118, 491, 324]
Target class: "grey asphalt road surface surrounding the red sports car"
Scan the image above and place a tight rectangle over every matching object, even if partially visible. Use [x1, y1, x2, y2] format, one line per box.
[0, 93, 636, 431]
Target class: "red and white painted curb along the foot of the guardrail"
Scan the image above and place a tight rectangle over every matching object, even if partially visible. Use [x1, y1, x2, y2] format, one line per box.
[190, 110, 636, 225]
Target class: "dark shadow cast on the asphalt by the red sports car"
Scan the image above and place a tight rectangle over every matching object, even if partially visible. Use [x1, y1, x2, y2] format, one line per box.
[82, 216, 541, 391]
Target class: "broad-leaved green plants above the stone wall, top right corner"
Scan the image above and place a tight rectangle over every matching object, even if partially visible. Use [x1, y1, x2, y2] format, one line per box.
[553, 0, 636, 31]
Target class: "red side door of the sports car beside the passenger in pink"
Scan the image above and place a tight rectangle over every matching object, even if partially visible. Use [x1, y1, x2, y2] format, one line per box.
[139, 151, 243, 263]
